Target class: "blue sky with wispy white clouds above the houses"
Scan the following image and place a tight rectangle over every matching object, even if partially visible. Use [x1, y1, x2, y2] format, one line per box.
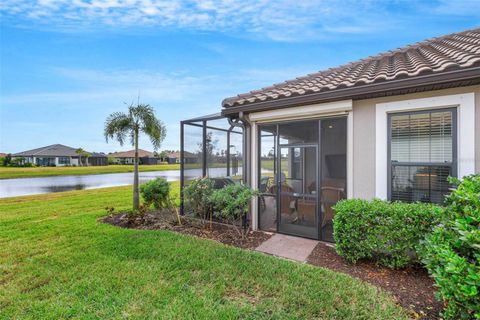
[0, 0, 480, 153]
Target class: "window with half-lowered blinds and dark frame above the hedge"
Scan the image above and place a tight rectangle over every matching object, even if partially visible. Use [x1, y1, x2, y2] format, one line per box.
[388, 109, 457, 204]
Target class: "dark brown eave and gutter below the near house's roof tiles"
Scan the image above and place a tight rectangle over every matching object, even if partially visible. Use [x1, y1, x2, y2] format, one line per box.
[222, 67, 480, 116]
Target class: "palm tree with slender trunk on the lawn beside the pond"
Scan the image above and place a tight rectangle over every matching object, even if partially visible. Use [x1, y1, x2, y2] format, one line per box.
[104, 103, 166, 211]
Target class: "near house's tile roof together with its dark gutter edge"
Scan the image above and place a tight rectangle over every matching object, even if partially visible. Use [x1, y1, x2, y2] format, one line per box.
[222, 28, 480, 115]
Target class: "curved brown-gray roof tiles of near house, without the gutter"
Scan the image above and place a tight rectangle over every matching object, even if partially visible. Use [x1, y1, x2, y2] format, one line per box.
[222, 28, 480, 112]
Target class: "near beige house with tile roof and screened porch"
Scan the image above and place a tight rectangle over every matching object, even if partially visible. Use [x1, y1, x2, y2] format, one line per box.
[181, 29, 480, 241]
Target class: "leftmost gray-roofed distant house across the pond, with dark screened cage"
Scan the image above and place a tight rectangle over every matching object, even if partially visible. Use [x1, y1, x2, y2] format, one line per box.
[12, 144, 107, 167]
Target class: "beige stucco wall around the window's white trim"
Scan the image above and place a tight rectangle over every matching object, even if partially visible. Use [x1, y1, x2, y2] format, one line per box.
[353, 85, 480, 199]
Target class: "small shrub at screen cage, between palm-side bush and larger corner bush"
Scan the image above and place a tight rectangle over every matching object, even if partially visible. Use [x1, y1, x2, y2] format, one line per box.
[183, 178, 215, 220]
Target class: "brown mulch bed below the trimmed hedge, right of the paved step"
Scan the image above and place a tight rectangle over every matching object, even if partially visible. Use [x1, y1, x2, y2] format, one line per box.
[307, 243, 442, 319]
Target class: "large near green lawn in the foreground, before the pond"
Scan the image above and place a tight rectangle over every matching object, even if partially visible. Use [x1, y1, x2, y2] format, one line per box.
[0, 183, 407, 319]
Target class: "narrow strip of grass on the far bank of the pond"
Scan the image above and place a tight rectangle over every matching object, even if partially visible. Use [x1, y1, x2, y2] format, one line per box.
[0, 164, 180, 179]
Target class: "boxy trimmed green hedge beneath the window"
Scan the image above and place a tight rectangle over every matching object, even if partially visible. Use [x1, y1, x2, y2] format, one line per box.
[333, 199, 441, 268]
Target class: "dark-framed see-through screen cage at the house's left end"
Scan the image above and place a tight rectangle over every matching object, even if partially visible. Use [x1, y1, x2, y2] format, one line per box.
[180, 113, 246, 214]
